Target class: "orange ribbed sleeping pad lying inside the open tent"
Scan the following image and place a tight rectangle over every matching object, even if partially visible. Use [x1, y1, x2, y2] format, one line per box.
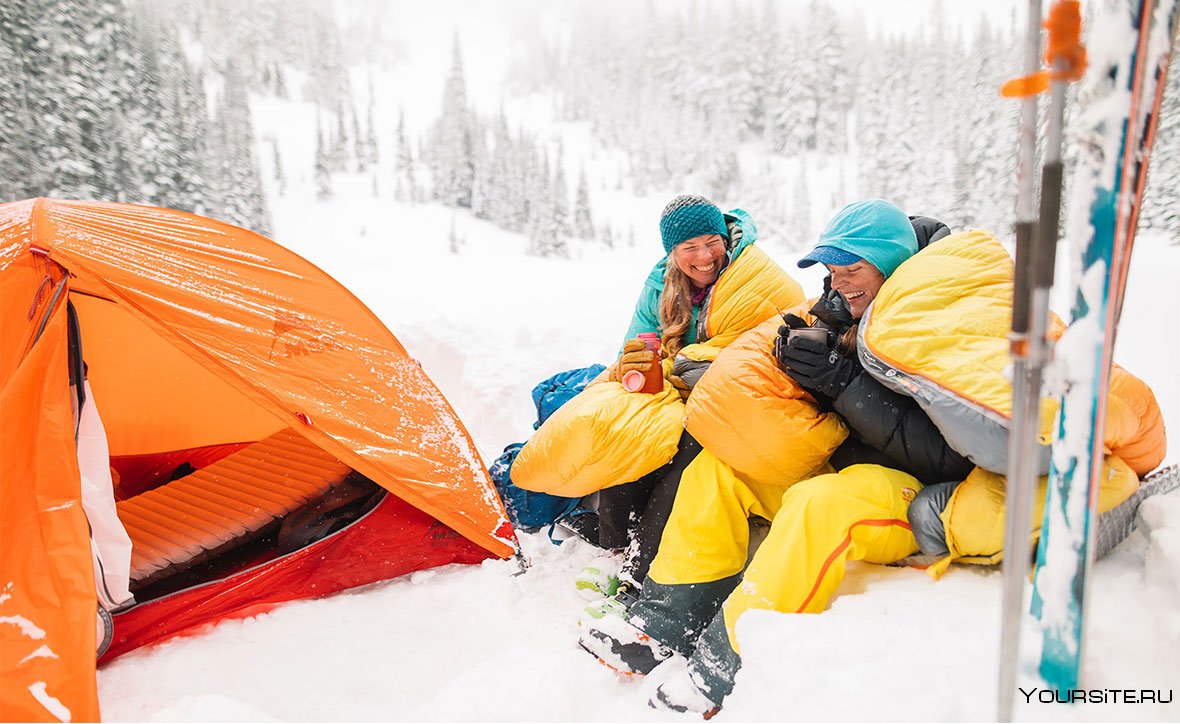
[118, 428, 352, 587]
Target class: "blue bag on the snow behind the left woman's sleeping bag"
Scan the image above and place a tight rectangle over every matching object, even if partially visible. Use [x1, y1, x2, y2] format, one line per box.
[487, 364, 607, 533]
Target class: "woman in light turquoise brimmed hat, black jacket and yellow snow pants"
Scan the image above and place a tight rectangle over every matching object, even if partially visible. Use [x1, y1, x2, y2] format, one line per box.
[579, 199, 972, 712]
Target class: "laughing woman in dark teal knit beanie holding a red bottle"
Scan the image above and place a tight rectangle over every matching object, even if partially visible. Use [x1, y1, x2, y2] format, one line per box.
[577, 195, 804, 597]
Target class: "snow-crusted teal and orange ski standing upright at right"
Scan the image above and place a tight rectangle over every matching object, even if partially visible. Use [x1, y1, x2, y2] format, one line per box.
[1025, 0, 1178, 692]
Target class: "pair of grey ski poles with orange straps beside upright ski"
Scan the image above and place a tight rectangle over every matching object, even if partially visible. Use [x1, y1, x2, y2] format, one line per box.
[996, 0, 1080, 722]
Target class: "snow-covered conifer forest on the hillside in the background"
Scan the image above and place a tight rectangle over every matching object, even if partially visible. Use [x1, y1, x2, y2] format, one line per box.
[0, 0, 1180, 251]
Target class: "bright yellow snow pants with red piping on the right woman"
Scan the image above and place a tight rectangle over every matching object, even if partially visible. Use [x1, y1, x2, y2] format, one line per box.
[648, 450, 922, 651]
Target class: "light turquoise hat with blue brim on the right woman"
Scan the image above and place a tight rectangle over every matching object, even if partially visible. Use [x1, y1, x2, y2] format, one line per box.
[799, 198, 918, 278]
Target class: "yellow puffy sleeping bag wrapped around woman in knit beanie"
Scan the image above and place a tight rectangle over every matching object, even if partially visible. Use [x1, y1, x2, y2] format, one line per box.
[512, 233, 804, 498]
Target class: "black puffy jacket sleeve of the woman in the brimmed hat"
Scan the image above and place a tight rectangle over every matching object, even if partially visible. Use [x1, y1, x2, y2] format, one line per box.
[833, 371, 975, 485]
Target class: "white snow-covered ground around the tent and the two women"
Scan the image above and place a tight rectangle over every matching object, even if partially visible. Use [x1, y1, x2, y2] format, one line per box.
[98, 4, 1180, 722]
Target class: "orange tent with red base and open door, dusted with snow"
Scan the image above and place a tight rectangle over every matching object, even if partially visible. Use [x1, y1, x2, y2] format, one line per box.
[0, 199, 514, 720]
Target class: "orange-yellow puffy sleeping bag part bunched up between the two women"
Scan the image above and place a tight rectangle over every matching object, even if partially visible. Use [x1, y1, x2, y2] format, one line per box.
[684, 311, 848, 486]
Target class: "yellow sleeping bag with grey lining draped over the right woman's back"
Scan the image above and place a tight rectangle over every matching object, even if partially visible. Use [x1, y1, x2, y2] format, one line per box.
[859, 231, 1165, 573]
